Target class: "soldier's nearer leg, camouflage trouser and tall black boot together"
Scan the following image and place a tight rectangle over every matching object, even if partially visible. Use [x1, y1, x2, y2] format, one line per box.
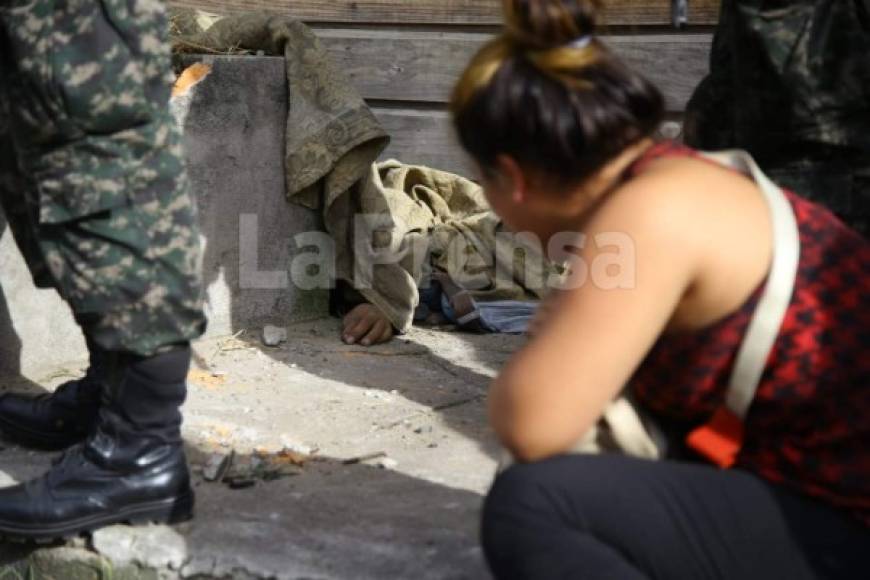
[0, 0, 205, 538]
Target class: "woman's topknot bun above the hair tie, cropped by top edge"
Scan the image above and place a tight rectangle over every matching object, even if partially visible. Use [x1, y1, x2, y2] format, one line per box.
[504, 0, 601, 50]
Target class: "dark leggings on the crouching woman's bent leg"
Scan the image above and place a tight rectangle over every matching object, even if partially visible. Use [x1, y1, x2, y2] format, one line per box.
[482, 455, 870, 580]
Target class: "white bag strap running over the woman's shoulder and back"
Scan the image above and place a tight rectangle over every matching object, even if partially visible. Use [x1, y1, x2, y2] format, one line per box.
[703, 151, 800, 419]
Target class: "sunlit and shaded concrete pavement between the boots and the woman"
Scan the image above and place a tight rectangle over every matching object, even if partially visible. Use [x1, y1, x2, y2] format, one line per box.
[0, 319, 523, 580]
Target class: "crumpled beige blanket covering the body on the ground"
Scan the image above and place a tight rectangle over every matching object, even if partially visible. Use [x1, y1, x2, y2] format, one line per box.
[346, 161, 556, 331]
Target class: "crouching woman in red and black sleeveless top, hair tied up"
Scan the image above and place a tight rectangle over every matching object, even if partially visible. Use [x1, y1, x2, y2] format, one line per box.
[452, 0, 870, 580]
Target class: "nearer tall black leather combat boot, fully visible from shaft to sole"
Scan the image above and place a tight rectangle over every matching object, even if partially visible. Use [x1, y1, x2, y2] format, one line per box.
[0, 347, 193, 541]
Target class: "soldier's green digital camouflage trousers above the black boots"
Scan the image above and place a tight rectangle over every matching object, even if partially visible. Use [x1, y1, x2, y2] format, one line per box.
[0, 0, 205, 356]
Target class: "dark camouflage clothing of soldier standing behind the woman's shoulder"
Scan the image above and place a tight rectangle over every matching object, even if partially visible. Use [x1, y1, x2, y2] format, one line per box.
[686, 0, 870, 235]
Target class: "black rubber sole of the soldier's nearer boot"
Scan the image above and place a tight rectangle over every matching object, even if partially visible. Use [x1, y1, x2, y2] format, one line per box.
[0, 491, 194, 544]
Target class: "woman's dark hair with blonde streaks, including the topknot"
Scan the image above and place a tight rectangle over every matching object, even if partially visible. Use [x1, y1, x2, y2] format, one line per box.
[450, 0, 664, 184]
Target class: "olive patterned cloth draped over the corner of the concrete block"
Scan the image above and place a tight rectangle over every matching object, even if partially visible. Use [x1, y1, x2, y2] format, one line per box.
[170, 9, 390, 214]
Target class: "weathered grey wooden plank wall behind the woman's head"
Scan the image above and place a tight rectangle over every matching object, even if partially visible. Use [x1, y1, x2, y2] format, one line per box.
[170, 0, 719, 175]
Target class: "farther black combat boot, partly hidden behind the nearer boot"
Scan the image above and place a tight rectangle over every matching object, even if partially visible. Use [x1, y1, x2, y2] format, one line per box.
[0, 341, 102, 451]
